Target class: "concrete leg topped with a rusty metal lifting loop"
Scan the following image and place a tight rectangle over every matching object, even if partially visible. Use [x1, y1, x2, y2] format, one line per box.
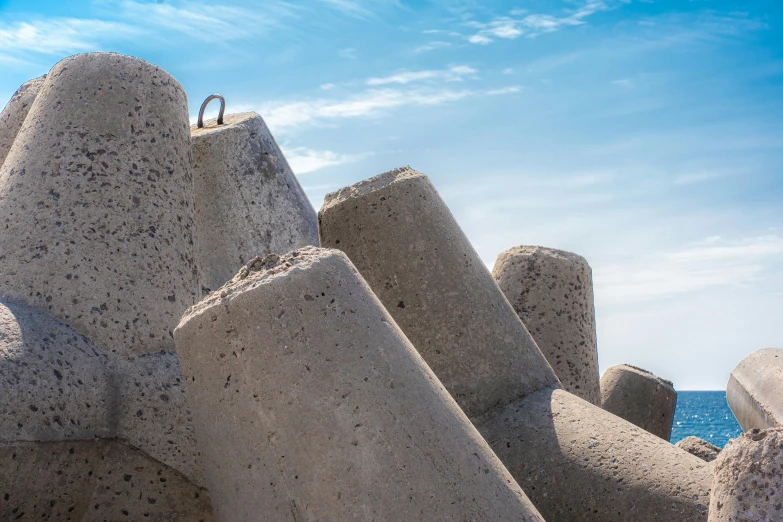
[191, 112, 318, 292]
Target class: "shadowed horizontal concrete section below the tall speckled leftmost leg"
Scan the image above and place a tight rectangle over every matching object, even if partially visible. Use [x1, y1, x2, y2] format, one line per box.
[0, 301, 205, 485]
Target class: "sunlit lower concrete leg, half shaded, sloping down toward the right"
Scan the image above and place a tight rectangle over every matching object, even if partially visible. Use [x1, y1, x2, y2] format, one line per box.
[477, 389, 712, 522]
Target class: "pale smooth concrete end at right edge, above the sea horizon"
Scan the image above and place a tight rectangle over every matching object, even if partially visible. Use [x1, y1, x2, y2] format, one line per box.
[726, 348, 783, 431]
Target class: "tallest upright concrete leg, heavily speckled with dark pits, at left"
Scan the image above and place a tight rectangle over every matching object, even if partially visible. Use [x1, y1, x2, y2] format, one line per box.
[0, 53, 198, 358]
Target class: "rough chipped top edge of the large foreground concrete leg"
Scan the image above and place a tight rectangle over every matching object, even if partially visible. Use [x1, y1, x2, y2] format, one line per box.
[181, 246, 353, 324]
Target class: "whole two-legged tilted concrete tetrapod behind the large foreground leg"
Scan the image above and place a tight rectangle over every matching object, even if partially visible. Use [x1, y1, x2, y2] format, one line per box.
[319, 168, 711, 522]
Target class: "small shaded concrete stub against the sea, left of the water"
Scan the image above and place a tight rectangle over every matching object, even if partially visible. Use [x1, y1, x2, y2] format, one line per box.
[601, 364, 677, 440]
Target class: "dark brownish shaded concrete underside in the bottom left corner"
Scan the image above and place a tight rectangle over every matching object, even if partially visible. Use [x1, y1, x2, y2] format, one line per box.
[0, 439, 213, 522]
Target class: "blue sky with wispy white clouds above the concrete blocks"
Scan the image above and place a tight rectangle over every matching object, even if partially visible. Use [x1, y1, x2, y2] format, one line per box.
[0, 0, 783, 389]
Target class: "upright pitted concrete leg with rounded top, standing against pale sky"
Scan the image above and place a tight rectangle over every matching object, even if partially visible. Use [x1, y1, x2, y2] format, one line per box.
[492, 246, 601, 406]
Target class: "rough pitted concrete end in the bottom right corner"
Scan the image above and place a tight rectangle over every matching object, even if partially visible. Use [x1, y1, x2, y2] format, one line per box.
[709, 427, 783, 522]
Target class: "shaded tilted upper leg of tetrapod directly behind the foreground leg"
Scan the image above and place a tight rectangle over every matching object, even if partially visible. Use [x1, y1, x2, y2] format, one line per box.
[319, 167, 557, 417]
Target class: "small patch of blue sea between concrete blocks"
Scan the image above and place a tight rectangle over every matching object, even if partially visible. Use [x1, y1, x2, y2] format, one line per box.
[670, 391, 742, 448]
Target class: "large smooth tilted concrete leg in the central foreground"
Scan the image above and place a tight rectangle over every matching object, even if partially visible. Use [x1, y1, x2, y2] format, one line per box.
[174, 247, 543, 521]
